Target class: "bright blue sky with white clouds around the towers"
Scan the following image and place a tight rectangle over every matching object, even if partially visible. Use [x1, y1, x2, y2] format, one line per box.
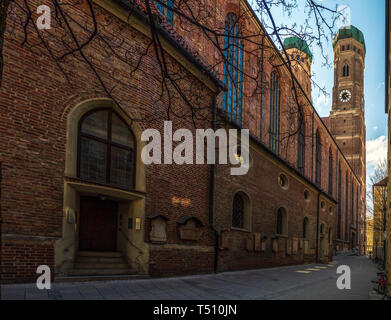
[262, 0, 387, 188]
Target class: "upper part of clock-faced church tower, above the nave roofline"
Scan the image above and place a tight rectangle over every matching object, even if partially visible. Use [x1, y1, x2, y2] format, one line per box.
[329, 26, 366, 182]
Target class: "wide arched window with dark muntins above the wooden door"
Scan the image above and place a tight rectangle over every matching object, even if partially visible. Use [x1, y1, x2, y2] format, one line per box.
[78, 109, 136, 189]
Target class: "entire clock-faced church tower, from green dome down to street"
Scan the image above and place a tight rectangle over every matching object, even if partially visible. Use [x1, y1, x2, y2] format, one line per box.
[328, 26, 366, 252]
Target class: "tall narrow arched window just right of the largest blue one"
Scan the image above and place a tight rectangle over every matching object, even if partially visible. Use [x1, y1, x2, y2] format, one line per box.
[269, 71, 280, 154]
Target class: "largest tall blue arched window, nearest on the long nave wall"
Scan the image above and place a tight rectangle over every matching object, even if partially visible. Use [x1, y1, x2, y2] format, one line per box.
[223, 13, 243, 125]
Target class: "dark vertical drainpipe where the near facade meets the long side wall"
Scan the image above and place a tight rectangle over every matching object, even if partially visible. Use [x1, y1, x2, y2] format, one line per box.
[209, 95, 219, 273]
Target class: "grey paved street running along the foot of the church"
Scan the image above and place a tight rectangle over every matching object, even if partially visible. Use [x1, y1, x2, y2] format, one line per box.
[2, 256, 377, 300]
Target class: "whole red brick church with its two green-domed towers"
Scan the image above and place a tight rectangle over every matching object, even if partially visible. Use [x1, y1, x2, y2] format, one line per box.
[0, 0, 365, 281]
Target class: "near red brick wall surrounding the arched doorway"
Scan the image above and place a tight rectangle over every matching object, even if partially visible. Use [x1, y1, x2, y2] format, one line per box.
[0, 1, 217, 281]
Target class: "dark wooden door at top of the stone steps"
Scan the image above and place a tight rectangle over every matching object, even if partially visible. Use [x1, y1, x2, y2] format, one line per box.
[79, 197, 118, 251]
